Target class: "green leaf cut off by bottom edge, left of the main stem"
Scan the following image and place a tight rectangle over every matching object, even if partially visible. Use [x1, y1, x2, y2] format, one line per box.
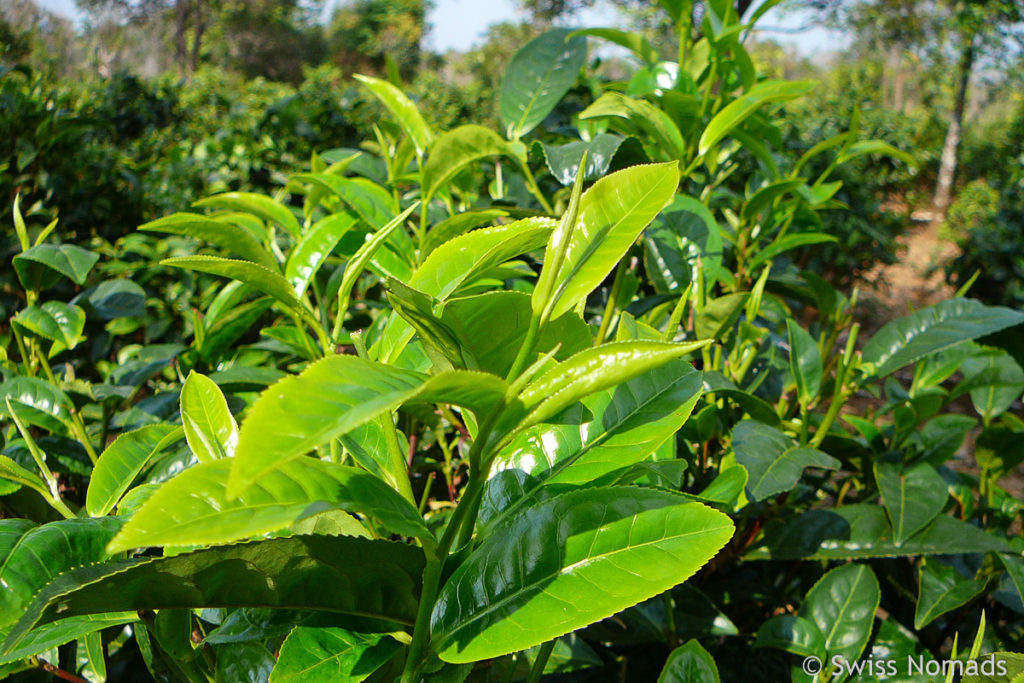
[270, 626, 400, 683]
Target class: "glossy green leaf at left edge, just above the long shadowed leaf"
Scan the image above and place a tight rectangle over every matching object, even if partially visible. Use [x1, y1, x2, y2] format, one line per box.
[0, 517, 122, 627]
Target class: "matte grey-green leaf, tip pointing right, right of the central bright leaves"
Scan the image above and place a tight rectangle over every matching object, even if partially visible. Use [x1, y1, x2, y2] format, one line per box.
[732, 420, 841, 501]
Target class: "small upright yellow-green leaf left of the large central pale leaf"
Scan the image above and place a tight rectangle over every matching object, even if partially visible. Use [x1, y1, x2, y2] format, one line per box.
[180, 371, 239, 463]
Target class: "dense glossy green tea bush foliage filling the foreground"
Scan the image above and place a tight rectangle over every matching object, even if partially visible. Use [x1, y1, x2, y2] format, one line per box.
[0, 1, 1024, 683]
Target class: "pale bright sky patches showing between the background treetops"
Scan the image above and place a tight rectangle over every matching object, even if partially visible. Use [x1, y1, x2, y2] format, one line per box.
[36, 0, 843, 56]
